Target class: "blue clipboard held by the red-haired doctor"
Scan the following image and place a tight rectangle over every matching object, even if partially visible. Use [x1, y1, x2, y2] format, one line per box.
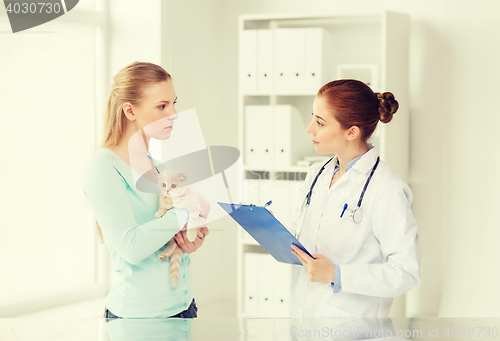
[217, 202, 314, 265]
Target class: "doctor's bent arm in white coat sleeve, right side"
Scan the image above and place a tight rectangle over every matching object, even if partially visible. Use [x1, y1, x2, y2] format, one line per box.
[340, 181, 420, 297]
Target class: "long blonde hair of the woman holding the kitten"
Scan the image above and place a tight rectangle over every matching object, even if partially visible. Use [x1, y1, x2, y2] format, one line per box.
[95, 62, 172, 244]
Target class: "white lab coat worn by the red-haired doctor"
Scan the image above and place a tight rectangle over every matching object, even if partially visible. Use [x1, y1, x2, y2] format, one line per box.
[290, 147, 420, 317]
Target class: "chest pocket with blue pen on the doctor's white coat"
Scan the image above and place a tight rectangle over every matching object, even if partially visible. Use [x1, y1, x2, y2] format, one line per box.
[318, 207, 366, 262]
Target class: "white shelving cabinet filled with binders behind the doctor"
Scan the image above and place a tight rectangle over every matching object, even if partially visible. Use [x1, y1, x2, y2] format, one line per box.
[235, 12, 409, 317]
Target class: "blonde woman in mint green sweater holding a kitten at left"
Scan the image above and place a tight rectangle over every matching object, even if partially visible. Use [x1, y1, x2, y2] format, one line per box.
[83, 62, 210, 318]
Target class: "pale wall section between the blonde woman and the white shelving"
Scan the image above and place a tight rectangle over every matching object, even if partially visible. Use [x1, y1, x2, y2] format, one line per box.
[162, 0, 237, 317]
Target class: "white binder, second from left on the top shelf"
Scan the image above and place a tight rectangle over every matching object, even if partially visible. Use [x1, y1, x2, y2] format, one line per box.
[257, 29, 274, 92]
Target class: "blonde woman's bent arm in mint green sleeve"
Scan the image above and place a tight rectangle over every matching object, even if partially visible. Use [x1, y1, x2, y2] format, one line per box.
[84, 158, 189, 264]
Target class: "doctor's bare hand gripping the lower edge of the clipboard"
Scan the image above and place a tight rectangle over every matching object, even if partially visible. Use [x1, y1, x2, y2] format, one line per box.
[292, 244, 335, 283]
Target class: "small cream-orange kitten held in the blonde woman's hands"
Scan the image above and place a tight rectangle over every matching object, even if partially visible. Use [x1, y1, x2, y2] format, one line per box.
[155, 171, 206, 287]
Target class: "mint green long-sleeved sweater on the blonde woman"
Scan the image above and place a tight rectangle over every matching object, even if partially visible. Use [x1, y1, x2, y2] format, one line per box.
[83, 148, 193, 318]
